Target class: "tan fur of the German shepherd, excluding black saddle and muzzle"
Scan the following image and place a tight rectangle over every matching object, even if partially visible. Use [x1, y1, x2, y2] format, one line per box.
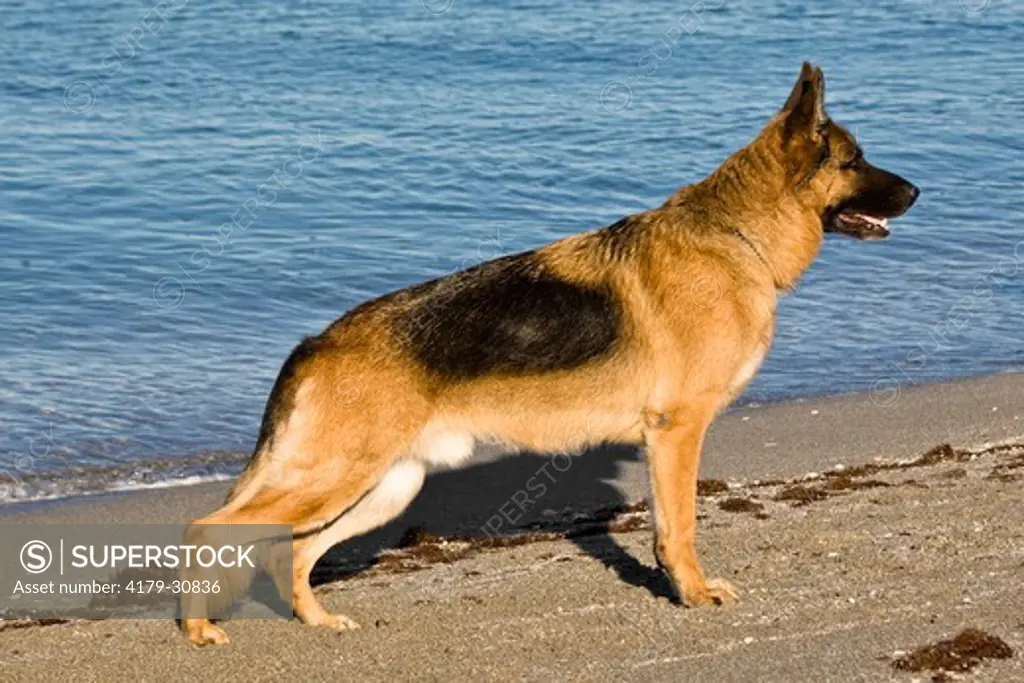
[183, 61, 905, 644]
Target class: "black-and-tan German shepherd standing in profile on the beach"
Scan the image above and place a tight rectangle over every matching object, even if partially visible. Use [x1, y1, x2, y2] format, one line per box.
[181, 62, 919, 645]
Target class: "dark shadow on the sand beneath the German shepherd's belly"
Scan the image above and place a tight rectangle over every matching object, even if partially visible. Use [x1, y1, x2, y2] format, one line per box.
[311, 444, 675, 599]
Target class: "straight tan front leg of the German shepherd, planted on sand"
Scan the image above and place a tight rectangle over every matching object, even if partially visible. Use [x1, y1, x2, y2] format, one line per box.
[644, 404, 736, 606]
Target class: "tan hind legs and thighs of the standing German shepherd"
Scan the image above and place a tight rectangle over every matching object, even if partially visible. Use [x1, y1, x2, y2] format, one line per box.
[181, 378, 429, 645]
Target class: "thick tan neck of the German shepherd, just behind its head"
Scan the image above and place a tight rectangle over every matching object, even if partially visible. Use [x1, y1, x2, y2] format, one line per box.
[666, 125, 824, 290]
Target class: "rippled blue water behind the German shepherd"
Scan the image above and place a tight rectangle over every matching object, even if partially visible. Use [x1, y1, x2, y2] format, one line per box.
[0, 0, 1024, 500]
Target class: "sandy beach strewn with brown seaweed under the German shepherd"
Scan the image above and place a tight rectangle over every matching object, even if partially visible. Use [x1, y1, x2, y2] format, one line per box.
[0, 374, 1024, 681]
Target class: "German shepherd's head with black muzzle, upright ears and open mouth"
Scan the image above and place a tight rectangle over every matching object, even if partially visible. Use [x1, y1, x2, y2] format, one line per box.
[776, 61, 920, 240]
